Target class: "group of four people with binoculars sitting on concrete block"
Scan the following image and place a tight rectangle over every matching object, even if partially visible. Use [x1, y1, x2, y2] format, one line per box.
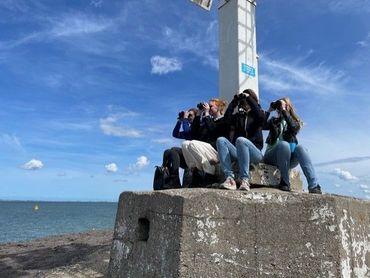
[158, 89, 321, 194]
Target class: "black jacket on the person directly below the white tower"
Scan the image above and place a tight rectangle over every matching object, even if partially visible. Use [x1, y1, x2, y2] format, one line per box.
[224, 96, 265, 150]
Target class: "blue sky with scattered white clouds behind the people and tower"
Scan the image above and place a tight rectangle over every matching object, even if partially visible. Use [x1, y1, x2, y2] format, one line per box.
[0, 0, 370, 201]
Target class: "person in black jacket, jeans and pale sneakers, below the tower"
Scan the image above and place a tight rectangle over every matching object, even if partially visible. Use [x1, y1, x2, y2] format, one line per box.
[217, 89, 265, 190]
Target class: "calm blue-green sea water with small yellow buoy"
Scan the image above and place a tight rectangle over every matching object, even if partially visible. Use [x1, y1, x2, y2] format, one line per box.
[0, 201, 117, 243]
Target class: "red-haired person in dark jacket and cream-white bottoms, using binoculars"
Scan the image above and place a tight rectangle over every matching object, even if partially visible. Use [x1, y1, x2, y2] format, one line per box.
[181, 98, 228, 186]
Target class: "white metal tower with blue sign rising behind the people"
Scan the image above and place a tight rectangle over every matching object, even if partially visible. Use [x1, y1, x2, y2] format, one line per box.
[191, 0, 258, 101]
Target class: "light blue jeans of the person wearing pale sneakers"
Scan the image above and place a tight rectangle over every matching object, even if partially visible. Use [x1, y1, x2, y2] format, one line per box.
[216, 137, 263, 179]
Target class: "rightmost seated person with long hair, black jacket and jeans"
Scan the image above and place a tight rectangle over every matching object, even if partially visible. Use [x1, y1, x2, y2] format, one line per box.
[263, 97, 321, 194]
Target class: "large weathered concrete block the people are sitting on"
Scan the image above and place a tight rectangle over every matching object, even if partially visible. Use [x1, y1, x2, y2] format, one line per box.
[108, 189, 370, 278]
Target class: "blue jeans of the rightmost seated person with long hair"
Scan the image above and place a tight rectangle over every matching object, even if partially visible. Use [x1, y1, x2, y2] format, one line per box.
[263, 141, 318, 189]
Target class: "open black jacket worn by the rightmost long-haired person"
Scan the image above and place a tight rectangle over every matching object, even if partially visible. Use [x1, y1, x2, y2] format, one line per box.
[263, 110, 301, 145]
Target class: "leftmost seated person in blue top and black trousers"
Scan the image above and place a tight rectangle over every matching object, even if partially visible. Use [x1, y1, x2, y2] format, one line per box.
[162, 108, 198, 189]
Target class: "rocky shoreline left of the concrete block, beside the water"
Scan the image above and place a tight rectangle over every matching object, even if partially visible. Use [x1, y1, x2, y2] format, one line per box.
[0, 231, 113, 277]
